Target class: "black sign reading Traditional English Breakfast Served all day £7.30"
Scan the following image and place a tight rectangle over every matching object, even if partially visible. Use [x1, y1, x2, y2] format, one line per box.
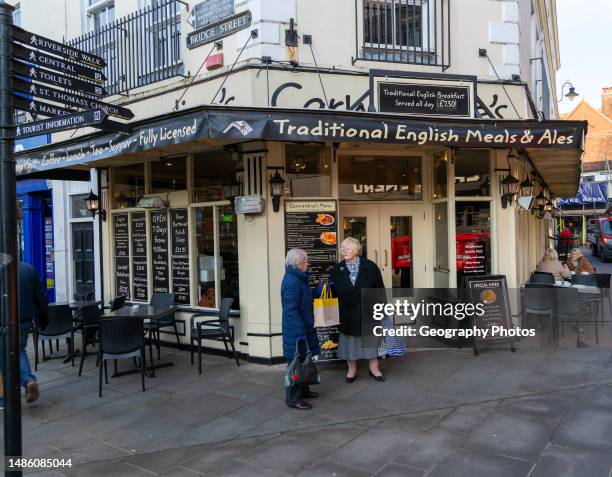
[378, 82, 472, 118]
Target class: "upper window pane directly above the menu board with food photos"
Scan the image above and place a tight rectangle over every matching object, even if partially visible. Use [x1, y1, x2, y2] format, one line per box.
[285, 144, 331, 197]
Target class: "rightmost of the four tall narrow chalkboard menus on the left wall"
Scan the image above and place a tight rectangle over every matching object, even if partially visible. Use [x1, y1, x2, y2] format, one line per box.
[170, 209, 190, 305]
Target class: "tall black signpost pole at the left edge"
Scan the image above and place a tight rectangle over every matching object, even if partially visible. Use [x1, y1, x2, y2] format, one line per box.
[0, 0, 22, 475]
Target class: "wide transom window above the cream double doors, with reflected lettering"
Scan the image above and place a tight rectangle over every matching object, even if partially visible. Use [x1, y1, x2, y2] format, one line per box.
[338, 156, 423, 200]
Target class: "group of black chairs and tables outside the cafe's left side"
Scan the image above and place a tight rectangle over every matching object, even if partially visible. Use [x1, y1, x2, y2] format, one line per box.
[33, 293, 240, 397]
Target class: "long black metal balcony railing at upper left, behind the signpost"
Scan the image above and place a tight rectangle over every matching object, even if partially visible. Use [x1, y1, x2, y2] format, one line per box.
[68, 0, 183, 95]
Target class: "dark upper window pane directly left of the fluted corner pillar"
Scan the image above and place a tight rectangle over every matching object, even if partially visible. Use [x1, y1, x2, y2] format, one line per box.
[193, 151, 236, 202]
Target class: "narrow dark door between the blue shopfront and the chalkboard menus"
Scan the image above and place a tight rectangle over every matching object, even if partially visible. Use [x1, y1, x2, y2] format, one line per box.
[72, 223, 96, 298]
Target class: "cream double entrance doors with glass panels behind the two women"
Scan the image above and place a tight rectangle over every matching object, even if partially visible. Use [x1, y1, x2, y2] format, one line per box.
[340, 204, 429, 288]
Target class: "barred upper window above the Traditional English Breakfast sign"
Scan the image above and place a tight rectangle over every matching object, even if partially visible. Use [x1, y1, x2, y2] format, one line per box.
[355, 0, 451, 70]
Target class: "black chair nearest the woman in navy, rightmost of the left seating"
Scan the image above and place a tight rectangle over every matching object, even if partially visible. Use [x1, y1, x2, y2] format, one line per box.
[190, 298, 240, 374]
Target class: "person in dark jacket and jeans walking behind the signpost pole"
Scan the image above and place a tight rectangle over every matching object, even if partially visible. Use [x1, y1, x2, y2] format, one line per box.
[0, 262, 49, 405]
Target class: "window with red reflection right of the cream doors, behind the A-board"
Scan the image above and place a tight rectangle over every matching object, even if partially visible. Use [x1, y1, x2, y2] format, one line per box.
[455, 202, 491, 286]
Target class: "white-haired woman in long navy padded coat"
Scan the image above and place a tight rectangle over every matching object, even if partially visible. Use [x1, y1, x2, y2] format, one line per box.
[281, 248, 321, 410]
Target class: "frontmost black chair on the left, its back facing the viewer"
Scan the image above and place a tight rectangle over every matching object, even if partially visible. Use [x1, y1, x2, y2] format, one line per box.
[98, 317, 146, 397]
